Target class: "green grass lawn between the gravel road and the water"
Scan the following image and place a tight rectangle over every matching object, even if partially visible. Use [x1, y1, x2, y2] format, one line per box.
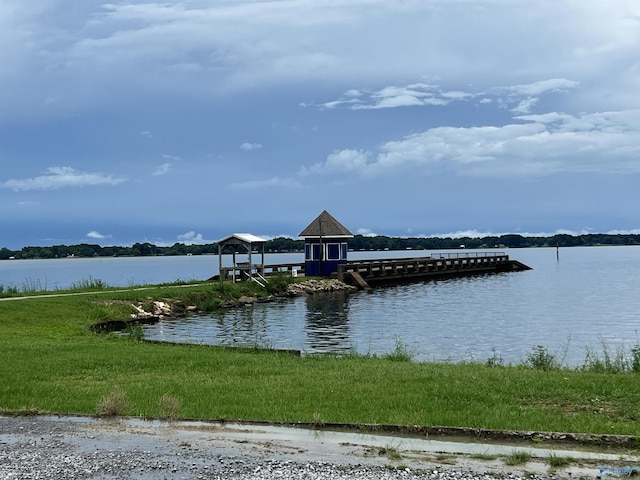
[0, 285, 640, 435]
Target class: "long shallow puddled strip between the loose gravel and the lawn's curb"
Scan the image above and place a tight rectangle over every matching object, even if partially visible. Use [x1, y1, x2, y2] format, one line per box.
[0, 416, 638, 476]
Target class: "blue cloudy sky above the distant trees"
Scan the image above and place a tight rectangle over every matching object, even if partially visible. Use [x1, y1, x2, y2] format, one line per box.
[0, 0, 640, 249]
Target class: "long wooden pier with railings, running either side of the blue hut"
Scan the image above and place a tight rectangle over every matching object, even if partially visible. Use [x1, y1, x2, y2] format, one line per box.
[220, 252, 531, 289]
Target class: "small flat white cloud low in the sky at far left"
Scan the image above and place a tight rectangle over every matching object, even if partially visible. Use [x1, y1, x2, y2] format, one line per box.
[0, 167, 126, 192]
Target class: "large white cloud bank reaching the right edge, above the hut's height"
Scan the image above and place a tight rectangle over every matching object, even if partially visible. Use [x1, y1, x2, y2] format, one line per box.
[300, 110, 640, 176]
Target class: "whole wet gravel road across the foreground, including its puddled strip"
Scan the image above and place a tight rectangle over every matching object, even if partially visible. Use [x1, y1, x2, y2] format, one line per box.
[0, 416, 618, 480]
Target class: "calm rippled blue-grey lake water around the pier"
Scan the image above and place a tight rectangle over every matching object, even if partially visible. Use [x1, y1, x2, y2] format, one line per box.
[0, 247, 640, 365]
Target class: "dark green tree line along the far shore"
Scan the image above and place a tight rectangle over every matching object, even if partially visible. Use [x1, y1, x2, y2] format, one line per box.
[0, 234, 640, 260]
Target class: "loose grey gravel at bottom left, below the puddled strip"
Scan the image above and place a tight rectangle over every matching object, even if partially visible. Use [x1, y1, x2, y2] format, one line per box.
[0, 416, 597, 480]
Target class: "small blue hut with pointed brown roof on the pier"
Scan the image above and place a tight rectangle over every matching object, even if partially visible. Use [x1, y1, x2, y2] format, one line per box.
[299, 210, 353, 277]
